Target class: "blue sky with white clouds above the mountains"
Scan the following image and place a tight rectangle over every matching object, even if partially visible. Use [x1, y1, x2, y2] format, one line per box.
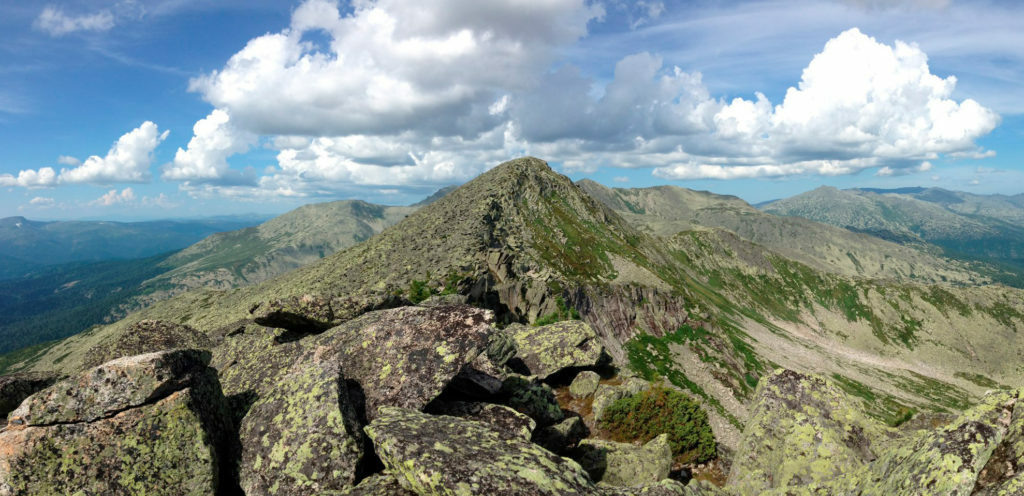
[0, 0, 1024, 220]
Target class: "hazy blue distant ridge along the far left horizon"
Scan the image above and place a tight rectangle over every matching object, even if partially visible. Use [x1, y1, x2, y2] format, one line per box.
[0, 217, 260, 279]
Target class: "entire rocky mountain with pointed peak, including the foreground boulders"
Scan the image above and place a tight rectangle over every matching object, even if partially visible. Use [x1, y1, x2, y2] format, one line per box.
[0, 158, 1024, 496]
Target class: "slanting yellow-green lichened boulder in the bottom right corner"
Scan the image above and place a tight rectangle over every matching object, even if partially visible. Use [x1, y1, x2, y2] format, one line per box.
[861, 391, 1020, 495]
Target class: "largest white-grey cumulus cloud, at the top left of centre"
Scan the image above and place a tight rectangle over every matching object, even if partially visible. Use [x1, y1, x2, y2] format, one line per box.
[190, 0, 601, 136]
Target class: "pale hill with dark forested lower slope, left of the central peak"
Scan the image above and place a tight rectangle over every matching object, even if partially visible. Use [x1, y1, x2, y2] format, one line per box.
[0, 189, 451, 353]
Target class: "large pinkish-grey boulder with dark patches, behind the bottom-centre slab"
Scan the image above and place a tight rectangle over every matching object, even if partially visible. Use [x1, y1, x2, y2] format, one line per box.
[319, 305, 494, 420]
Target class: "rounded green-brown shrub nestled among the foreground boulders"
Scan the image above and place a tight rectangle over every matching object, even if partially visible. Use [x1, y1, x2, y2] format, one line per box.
[599, 385, 716, 462]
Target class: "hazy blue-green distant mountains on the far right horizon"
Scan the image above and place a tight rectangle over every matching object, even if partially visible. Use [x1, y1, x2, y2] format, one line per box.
[762, 188, 1024, 274]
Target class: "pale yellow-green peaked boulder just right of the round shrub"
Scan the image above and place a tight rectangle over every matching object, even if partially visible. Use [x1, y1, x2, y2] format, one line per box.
[729, 370, 894, 494]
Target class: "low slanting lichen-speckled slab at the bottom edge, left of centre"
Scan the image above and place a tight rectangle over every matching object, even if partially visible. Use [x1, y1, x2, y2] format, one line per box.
[366, 408, 596, 496]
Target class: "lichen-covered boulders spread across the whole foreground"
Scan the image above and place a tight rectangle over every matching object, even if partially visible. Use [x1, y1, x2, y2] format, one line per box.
[0, 296, 1024, 496]
